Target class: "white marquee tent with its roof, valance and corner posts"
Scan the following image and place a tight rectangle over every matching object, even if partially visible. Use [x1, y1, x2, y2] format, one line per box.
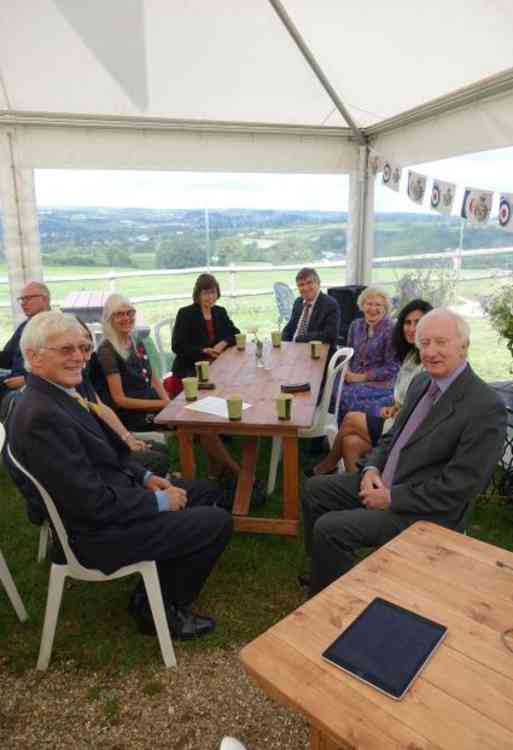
[0, 0, 513, 314]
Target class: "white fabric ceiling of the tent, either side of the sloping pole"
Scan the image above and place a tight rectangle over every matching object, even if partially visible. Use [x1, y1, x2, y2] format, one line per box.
[0, 0, 513, 126]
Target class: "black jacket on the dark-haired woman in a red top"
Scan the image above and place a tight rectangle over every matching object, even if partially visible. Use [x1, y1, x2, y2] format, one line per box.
[171, 302, 239, 378]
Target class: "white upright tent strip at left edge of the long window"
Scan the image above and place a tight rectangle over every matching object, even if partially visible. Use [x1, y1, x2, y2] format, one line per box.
[0, 128, 43, 323]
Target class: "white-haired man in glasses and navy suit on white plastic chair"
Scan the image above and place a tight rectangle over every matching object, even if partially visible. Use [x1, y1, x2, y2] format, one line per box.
[9, 312, 232, 639]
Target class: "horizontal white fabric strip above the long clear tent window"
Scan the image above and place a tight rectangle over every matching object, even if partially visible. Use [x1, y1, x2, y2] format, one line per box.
[3, 125, 358, 174]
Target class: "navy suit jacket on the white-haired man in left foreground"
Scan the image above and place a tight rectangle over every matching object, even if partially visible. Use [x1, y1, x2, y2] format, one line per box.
[9, 374, 159, 573]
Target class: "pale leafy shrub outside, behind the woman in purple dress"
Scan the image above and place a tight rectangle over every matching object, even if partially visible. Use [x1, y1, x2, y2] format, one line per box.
[394, 268, 456, 310]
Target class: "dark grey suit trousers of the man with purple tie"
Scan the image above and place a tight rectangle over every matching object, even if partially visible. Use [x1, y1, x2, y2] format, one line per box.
[302, 473, 412, 596]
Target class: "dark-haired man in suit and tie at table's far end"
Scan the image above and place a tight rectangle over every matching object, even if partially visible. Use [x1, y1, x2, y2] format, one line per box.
[281, 268, 340, 348]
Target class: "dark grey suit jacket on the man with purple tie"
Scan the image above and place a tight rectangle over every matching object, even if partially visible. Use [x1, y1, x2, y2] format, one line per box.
[364, 365, 506, 528]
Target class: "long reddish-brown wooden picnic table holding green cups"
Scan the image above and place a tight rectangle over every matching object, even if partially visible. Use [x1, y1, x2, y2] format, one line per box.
[155, 342, 328, 536]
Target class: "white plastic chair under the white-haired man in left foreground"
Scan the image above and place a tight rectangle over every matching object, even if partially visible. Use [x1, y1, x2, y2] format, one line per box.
[7, 445, 176, 670]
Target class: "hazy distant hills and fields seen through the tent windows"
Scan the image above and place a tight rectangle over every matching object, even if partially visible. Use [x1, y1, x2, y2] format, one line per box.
[0, 206, 513, 268]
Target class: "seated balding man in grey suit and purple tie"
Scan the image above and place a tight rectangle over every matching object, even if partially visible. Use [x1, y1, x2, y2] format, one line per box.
[303, 308, 506, 595]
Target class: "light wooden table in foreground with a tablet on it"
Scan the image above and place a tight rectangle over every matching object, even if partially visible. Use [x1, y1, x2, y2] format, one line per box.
[241, 522, 513, 750]
